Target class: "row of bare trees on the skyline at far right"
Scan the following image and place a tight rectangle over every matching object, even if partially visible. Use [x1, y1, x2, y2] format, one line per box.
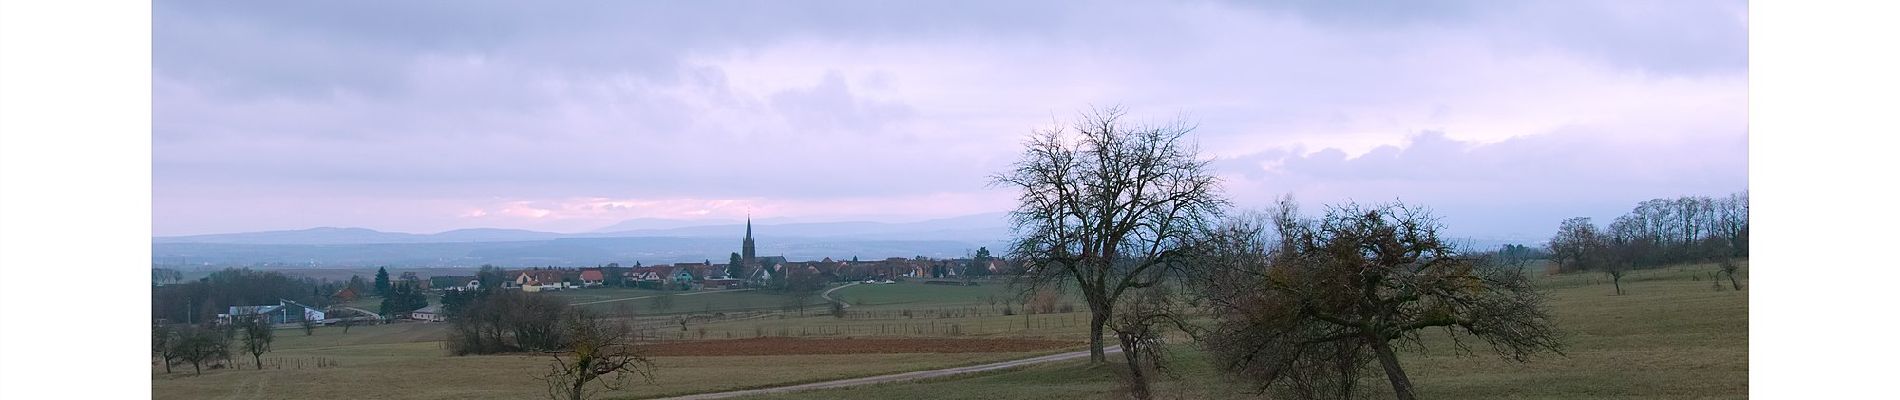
[1549, 191, 1748, 294]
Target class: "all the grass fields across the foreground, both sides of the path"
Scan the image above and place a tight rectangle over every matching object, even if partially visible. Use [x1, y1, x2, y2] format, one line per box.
[152, 265, 1748, 400]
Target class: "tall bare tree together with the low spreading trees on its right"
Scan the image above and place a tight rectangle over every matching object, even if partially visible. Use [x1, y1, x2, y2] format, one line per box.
[992, 108, 1562, 398]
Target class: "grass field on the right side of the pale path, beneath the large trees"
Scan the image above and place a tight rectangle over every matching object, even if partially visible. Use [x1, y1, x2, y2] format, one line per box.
[756, 265, 1748, 400]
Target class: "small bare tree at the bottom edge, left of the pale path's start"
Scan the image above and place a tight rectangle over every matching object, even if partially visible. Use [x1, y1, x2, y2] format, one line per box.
[542, 309, 654, 400]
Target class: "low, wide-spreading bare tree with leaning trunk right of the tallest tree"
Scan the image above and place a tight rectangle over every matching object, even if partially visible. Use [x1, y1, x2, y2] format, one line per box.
[1201, 199, 1562, 400]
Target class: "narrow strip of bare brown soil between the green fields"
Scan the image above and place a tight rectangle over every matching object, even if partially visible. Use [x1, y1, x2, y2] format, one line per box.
[640, 337, 1083, 356]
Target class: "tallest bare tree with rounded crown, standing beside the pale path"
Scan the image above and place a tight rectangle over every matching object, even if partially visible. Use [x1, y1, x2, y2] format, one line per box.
[992, 108, 1227, 362]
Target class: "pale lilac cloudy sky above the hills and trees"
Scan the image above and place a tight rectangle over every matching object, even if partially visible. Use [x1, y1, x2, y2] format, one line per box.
[152, 0, 1748, 237]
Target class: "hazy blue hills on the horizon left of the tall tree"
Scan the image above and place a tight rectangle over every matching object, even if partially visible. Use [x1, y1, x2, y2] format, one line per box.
[152, 212, 1009, 267]
